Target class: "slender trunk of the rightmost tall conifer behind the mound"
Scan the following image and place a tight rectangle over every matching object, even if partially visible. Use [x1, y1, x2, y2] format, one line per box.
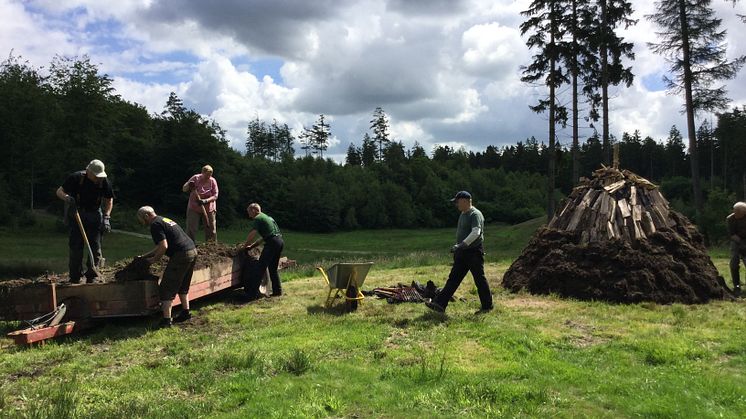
[679, 0, 703, 222]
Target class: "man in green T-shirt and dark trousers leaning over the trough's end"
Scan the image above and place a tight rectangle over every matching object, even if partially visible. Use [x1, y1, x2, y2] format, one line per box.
[244, 203, 285, 299]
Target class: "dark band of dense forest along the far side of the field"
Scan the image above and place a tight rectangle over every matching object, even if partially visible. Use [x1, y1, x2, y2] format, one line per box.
[0, 52, 746, 243]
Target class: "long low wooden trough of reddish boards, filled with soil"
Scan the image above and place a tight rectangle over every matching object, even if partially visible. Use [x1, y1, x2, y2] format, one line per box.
[0, 257, 241, 344]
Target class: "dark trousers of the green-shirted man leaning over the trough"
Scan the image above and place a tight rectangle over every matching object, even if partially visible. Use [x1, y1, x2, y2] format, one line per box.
[241, 236, 285, 298]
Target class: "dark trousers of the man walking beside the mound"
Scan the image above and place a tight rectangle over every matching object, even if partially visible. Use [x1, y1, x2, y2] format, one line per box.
[435, 246, 492, 308]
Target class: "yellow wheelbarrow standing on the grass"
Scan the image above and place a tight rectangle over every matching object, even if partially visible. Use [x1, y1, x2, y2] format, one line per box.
[316, 262, 373, 311]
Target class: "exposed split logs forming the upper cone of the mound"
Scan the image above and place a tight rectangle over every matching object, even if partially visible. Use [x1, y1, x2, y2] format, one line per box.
[549, 166, 676, 244]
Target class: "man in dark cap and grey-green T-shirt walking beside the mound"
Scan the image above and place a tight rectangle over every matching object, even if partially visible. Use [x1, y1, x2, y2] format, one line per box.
[425, 191, 492, 313]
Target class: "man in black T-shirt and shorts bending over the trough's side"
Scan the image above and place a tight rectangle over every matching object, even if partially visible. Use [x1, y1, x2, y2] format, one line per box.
[137, 206, 197, 327]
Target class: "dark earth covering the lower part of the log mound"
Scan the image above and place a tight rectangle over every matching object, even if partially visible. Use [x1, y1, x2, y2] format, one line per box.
[502, 211, 732, 304]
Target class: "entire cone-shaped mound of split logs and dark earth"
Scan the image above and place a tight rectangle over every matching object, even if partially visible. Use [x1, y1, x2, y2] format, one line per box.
[502, 168, 732, 304]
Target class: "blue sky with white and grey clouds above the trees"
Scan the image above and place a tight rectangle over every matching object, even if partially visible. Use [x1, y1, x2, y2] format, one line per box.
[0, 0, 746, 161]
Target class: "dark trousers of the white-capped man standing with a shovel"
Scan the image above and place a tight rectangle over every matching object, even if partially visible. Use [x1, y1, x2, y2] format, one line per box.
[68, 210, 103, 282]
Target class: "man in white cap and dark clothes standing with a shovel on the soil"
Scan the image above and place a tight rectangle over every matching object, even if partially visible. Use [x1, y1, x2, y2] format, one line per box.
[57, 160, 114, 284]
